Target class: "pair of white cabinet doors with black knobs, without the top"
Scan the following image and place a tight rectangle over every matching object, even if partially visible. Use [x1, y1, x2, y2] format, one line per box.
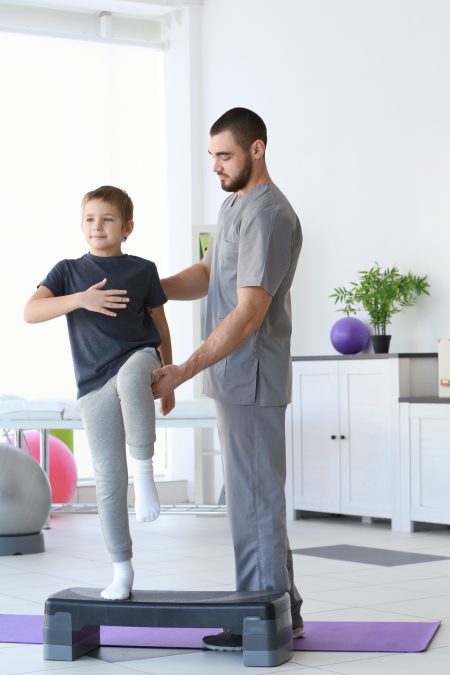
[292, 359, 395, 518]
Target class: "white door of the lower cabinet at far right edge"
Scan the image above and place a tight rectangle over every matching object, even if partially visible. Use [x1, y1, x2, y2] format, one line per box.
[410, 403, 450, 524]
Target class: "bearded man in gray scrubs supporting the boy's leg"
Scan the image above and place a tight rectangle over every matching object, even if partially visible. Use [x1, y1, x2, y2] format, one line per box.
[153, 108, 303, 650]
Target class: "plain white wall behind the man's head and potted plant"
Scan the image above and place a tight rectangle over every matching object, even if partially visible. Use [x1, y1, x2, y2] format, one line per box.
[201, 0, 450, 354]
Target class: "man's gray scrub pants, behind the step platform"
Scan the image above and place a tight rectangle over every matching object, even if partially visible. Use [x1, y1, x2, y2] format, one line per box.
[216, 401, 302, 627]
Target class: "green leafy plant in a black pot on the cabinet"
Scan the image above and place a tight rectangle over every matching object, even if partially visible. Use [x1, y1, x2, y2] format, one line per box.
[330, 263, 430, 353]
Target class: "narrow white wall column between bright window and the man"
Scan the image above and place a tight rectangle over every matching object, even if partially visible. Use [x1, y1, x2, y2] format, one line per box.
[162, 7, 205, 501]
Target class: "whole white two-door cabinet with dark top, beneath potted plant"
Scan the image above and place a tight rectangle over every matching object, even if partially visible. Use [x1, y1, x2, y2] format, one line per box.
[286, 354, 438, 529]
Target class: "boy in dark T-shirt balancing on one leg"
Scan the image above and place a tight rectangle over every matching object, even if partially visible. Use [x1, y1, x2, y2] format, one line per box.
[24, 185, 175, 600]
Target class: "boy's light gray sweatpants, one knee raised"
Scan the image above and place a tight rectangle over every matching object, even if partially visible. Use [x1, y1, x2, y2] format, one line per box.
[78, 347, 161, 562]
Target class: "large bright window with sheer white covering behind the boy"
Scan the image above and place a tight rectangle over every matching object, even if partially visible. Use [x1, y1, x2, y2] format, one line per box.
[0, 33, 166, 476]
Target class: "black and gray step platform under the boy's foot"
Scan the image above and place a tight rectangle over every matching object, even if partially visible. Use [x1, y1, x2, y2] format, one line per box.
[44, 588, 293, 666]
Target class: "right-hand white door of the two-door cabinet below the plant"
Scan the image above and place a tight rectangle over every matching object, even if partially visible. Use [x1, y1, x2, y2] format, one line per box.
[338, 359, 392, 518]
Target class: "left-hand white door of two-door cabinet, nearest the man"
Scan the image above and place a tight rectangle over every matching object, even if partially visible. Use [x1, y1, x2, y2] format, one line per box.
[292, 361, 340, 513]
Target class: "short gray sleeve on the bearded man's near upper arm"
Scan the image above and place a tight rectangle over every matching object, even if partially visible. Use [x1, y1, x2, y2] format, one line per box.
[237, 209, 293, 297]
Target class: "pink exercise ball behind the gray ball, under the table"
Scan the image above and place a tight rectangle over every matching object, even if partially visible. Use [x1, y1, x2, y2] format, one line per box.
[25, 431, 78, 504]
